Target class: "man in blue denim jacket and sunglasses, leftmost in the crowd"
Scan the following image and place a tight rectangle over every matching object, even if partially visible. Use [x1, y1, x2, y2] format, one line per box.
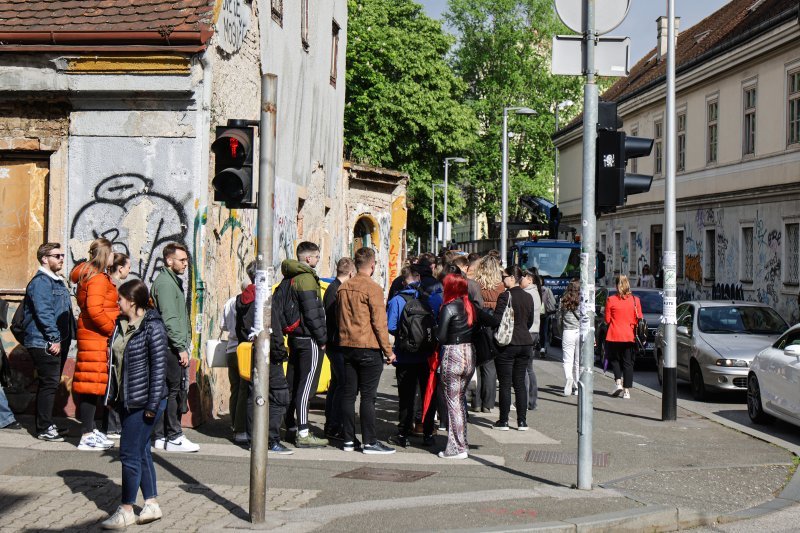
[21, 242, 76, 442]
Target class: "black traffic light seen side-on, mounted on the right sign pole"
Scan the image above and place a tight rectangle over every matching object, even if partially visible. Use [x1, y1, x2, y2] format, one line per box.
[595, 102, 653, 216]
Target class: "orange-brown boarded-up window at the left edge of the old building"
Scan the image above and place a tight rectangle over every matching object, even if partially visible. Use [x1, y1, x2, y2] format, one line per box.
[0, 158, 50, 292]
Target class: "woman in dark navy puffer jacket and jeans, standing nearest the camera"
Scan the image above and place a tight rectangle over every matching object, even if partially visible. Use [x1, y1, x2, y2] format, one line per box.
[103, 279, 169, 529]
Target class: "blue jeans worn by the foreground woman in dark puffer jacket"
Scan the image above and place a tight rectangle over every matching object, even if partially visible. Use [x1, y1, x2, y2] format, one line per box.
[119, 398, 167, 505]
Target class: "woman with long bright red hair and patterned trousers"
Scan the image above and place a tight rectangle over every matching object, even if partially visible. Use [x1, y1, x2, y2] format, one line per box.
[436, 274, 476, 459]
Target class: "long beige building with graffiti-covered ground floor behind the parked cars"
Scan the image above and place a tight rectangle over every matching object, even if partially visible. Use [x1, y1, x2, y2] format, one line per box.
[555, 0, 800, 322]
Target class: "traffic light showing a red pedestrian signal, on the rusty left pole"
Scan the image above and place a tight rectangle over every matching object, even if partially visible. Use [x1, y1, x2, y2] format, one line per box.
[211, 121, 255, 209]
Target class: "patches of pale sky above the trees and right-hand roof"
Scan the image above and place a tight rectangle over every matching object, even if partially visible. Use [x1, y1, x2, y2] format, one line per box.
[416, 0, 729, 66]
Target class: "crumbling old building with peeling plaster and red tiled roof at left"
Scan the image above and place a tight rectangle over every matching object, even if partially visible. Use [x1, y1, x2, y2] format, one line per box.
[0, 0, 405, 423]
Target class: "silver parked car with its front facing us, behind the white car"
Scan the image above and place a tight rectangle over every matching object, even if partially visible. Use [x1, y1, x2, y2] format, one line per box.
[656, 300, 789, 401]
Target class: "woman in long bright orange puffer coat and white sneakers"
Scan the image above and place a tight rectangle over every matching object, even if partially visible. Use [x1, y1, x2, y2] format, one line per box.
[70, 239, 119, 451]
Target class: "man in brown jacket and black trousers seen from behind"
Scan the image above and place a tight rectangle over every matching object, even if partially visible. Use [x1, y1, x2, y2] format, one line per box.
[336, 248, 395, 454]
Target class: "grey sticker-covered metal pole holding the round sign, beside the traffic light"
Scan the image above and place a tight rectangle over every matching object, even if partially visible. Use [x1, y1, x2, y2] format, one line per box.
[578, 0, 598, 490]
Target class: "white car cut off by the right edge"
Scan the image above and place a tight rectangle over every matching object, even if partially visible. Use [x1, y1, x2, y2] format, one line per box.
[747, 324, 800, 426]
